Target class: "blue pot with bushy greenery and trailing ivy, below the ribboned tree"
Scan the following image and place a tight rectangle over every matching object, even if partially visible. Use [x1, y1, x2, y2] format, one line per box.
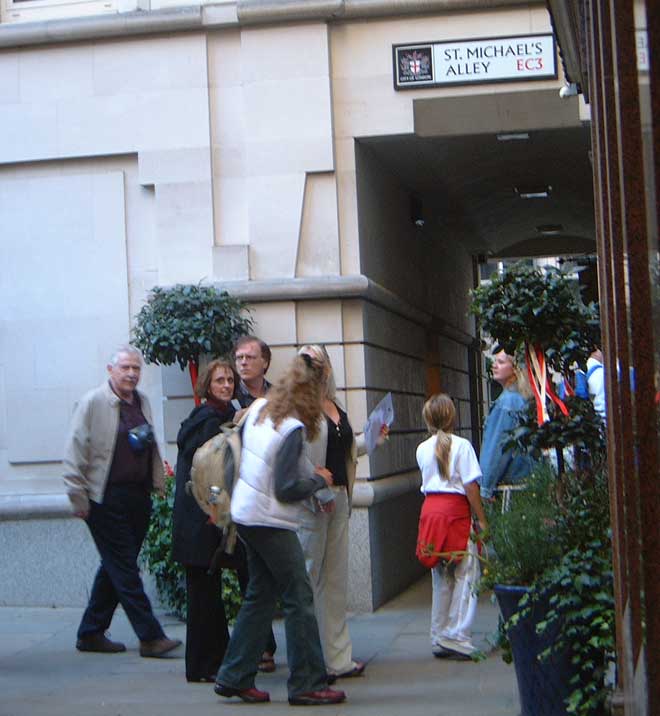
[482, 458, 615, 716]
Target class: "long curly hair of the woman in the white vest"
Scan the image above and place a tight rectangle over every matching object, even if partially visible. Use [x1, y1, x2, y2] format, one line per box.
[257, 354, 325, 442]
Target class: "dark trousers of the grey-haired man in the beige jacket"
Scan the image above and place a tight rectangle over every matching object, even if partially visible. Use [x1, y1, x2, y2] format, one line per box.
[78, 485, 164, 641]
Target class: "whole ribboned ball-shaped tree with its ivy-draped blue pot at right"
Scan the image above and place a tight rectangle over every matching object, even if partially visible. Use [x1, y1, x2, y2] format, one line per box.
[472, 264, 614, 716]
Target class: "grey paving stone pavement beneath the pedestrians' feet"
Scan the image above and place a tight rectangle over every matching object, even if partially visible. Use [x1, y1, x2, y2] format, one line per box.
[0, 577, 519, 716]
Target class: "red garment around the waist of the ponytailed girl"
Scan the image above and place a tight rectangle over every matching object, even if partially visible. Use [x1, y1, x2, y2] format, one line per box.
[416, 492, 472, 569]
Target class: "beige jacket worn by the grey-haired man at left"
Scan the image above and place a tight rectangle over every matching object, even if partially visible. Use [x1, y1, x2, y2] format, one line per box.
[63, 381, 165, 512]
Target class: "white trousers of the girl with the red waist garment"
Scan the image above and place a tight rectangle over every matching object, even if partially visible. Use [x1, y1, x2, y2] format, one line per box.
[431, 541, 481, 654]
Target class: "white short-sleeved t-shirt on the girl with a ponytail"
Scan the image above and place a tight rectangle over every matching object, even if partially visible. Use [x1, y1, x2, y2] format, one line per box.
[416, 435, 481, 495]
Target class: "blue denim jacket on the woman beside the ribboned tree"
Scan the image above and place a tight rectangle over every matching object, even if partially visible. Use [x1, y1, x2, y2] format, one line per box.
[479, 388, 533, 498]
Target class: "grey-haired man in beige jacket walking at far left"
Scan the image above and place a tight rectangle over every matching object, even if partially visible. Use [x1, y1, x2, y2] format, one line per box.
[64, 345, 181, 658]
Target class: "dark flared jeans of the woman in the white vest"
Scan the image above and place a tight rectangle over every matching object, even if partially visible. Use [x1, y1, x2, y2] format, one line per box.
[217, 525, 327, 698]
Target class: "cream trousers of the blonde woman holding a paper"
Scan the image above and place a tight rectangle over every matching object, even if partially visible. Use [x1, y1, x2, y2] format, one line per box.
[298, 487, 355, 674]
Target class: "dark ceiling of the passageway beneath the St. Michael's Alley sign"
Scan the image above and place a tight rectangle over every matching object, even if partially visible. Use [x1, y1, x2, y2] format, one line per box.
[359, 112, 596, 257]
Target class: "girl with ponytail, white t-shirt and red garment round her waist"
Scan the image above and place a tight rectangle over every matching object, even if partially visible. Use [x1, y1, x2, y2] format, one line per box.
[417, 393, 487, 659]
